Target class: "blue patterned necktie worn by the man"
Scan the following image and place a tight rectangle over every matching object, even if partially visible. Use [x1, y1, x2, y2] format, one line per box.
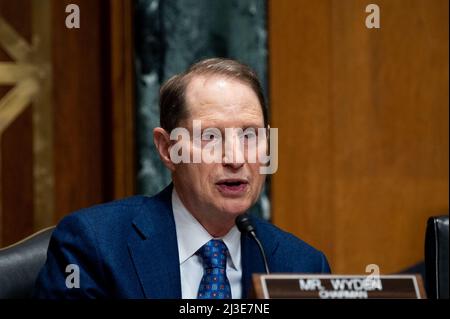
[197, 239, 231, 299]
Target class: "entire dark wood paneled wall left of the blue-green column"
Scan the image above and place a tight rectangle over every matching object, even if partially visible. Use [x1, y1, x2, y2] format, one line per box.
[0, 0, 135, 247]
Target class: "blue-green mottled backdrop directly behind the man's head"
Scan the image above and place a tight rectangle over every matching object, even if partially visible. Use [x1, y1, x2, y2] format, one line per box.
[134, 0, 270, 218]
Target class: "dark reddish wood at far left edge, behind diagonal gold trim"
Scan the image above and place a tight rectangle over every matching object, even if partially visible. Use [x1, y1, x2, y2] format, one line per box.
[0, 0, 34, 246]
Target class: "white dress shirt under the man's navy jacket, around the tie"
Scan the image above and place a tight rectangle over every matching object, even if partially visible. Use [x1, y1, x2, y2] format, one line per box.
[172, 188, 242, 299]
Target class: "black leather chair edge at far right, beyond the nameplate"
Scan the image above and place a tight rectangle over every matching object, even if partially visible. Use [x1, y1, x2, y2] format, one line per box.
[425, 215, 449, 299]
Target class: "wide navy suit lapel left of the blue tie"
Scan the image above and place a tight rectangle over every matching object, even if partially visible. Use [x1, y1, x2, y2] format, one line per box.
[128, 185, 181, 298]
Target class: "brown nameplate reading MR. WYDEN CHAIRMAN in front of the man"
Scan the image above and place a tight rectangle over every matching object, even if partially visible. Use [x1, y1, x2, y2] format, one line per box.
[253, 274, 426, 299]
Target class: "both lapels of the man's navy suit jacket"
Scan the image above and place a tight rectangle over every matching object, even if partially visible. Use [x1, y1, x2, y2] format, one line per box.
[128, 184, 278, 299]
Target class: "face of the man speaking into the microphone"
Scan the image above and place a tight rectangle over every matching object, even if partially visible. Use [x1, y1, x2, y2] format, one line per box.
[173, 76, 267, 220]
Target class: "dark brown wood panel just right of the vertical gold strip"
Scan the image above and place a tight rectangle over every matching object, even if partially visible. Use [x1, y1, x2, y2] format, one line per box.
[53, 0, 110, 222]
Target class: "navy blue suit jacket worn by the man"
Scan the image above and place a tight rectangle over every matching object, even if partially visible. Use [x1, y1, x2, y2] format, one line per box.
[34, 185, 330, 298]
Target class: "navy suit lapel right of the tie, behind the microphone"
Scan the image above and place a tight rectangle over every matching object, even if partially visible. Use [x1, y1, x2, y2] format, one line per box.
[241, 224, 278, 298]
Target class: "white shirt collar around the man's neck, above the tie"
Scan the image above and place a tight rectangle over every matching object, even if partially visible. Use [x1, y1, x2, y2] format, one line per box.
[172, 187, 241, 269]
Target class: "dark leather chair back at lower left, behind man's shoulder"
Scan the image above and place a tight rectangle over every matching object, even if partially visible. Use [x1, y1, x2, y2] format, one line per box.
[0, 227, 55, 299]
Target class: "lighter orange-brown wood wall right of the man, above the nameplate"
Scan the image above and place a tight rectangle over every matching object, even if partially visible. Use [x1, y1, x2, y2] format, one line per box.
[269, 0, 449, 273]
